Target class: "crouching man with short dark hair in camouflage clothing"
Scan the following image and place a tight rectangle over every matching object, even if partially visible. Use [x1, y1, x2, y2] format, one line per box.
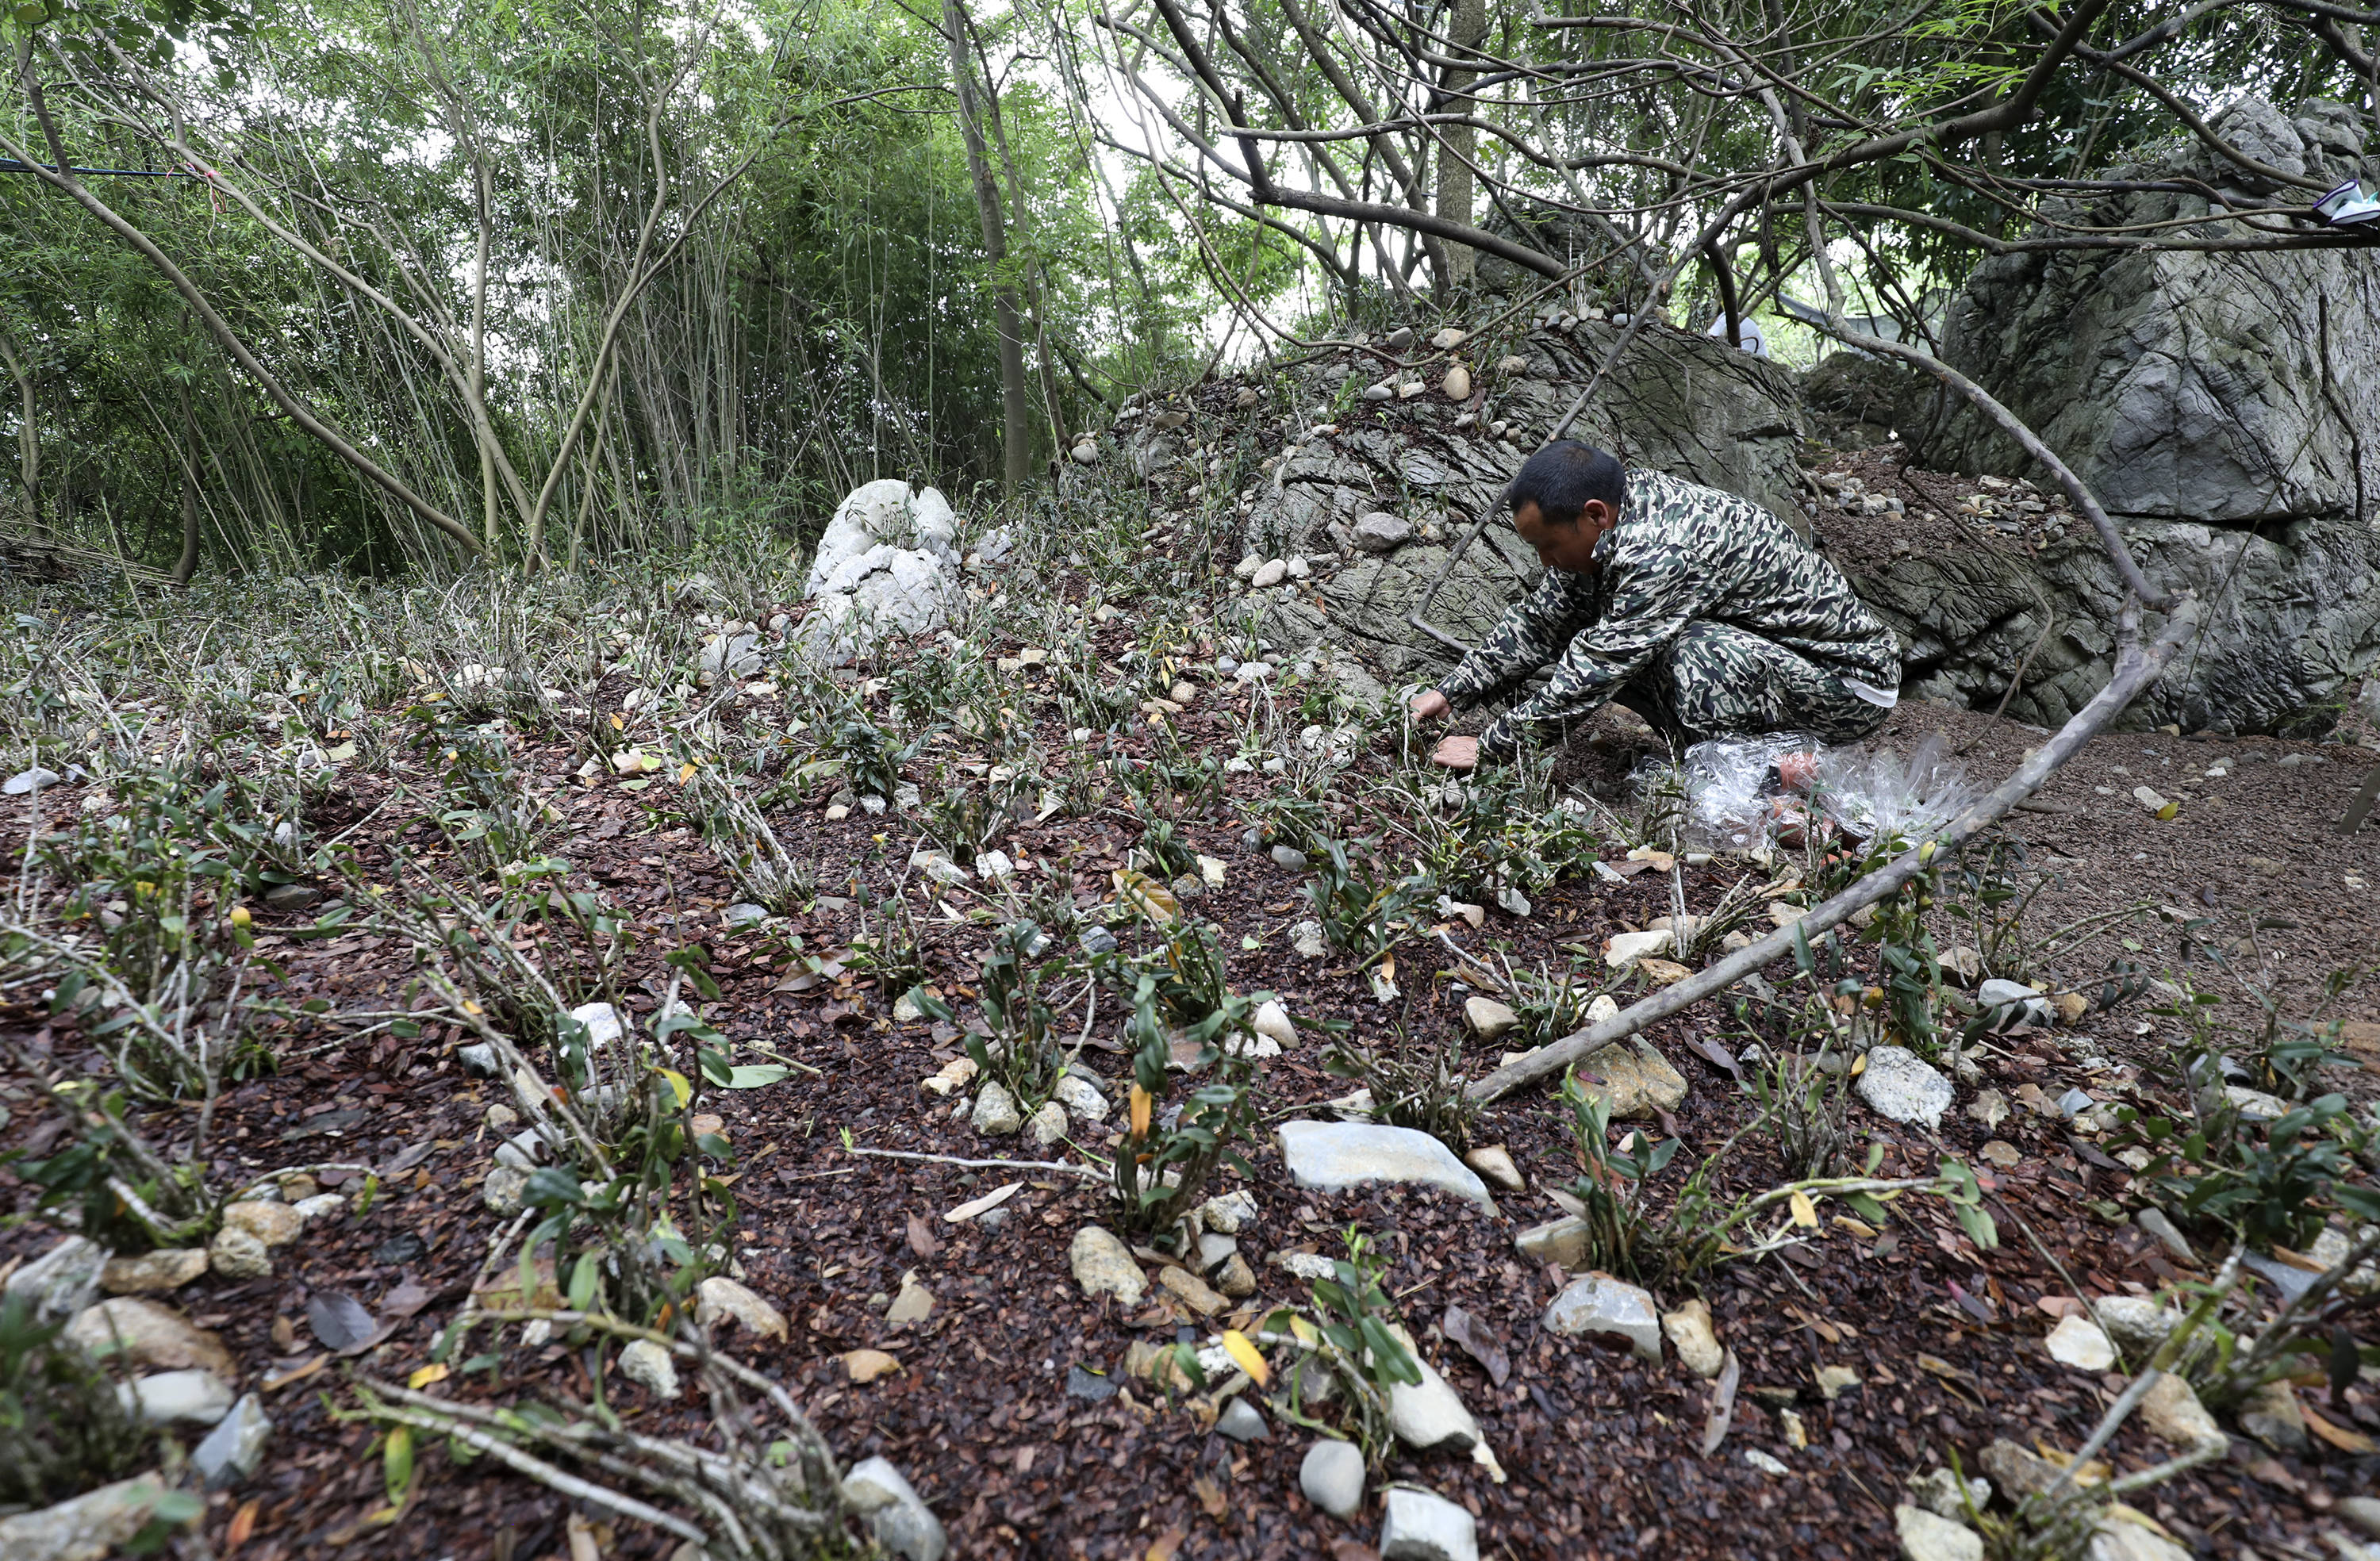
[1411, 440, 1902, 769]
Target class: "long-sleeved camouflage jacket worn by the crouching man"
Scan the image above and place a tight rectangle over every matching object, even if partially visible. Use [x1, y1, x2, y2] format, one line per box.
[1438, 469, 1902, 757]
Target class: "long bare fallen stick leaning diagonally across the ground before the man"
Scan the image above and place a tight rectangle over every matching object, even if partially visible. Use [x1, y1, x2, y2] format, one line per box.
[1466, 600, 2199, 1102]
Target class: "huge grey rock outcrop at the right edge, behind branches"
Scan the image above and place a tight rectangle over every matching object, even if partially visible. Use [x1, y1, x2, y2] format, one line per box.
[1894, 98, 2380, 733]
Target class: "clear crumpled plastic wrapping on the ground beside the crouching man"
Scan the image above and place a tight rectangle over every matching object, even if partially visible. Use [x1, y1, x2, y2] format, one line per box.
[1633, 733, 1978, 852]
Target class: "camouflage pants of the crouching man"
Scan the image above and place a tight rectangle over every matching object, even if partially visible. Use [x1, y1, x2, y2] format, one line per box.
[1616, 621, 1892, 745]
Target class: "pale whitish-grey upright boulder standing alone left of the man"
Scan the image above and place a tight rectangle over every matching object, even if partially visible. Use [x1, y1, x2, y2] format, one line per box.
[795, 478, 959, 662]
